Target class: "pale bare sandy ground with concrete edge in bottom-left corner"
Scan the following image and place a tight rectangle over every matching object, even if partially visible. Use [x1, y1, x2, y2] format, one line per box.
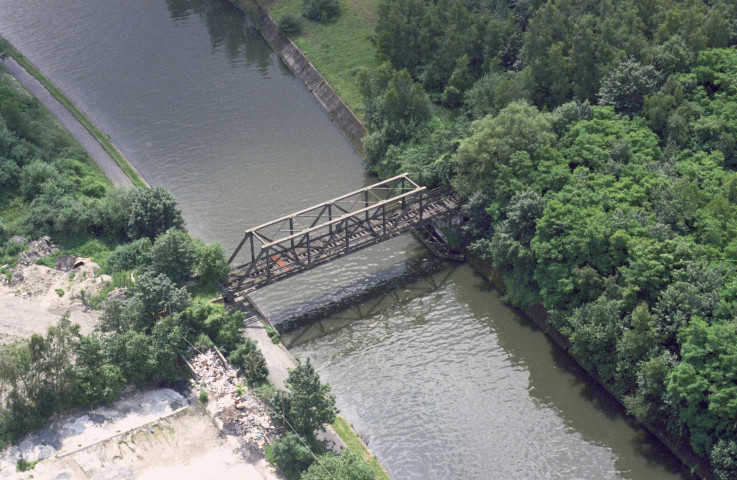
[0, 389, 278, 480]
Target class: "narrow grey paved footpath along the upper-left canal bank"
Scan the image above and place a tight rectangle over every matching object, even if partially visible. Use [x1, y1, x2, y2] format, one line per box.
[0, 57, 133, 186]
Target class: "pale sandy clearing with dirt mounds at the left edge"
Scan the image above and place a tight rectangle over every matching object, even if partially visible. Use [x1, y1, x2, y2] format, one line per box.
[0, 259, 111, 343]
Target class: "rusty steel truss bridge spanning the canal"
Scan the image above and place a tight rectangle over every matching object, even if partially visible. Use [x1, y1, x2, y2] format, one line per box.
[221, 174, 461, 301]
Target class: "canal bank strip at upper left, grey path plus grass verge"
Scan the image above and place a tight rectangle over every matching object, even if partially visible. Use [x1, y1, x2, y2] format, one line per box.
[0, 36, 150, 187]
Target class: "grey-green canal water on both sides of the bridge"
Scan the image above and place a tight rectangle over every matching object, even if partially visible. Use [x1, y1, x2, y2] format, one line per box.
[0, 0, 682, 480]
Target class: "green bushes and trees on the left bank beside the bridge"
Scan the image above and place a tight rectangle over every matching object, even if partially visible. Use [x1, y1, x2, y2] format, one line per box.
[0, 57, 247, 446]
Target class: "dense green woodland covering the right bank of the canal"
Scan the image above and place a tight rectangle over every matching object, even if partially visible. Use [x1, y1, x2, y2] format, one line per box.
[300, 0, 737, 478]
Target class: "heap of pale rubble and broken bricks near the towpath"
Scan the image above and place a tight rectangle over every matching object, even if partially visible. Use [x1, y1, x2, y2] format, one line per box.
[191, 349, 280, 450]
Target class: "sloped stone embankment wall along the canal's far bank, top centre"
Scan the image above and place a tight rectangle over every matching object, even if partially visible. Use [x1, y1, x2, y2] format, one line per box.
[221, 0, 368, 152]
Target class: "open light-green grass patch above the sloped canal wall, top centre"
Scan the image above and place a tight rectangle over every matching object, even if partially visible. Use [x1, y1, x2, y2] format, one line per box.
[259, 0, 378, 119]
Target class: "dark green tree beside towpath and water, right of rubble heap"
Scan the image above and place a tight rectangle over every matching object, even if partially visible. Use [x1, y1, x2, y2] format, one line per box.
[284, 358, 337, 437]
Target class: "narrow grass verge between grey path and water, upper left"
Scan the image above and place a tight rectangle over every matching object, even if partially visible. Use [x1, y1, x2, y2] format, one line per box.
[0, 36, 148, 187]
